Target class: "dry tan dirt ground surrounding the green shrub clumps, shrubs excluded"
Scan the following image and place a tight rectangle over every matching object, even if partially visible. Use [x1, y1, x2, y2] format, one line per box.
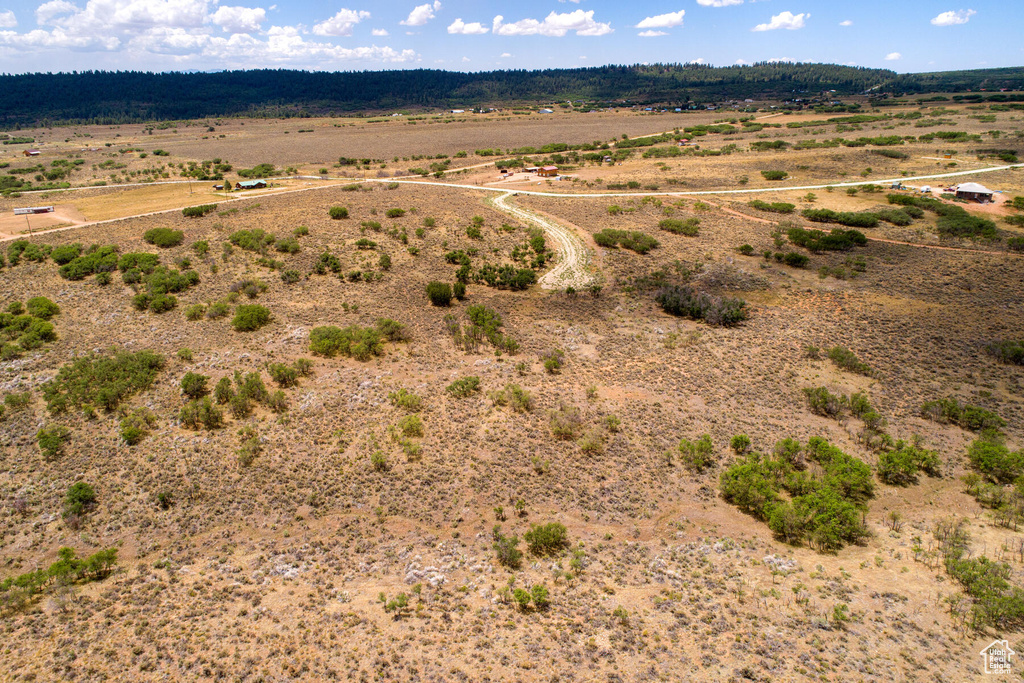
[0, 101, 1024, 683]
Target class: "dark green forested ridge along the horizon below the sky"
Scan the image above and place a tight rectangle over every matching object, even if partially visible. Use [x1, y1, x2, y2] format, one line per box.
[0, 62, 1024, 129]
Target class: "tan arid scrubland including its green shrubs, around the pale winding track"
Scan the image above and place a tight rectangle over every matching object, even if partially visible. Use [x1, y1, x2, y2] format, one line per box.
[0, 102, 1024, 682]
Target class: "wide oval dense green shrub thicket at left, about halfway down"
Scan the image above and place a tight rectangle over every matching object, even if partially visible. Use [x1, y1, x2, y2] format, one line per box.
[42, 351, 164, 413]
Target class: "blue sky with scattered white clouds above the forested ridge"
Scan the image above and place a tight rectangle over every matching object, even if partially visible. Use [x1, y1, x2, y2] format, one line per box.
[0, 0, 1024, 73]
